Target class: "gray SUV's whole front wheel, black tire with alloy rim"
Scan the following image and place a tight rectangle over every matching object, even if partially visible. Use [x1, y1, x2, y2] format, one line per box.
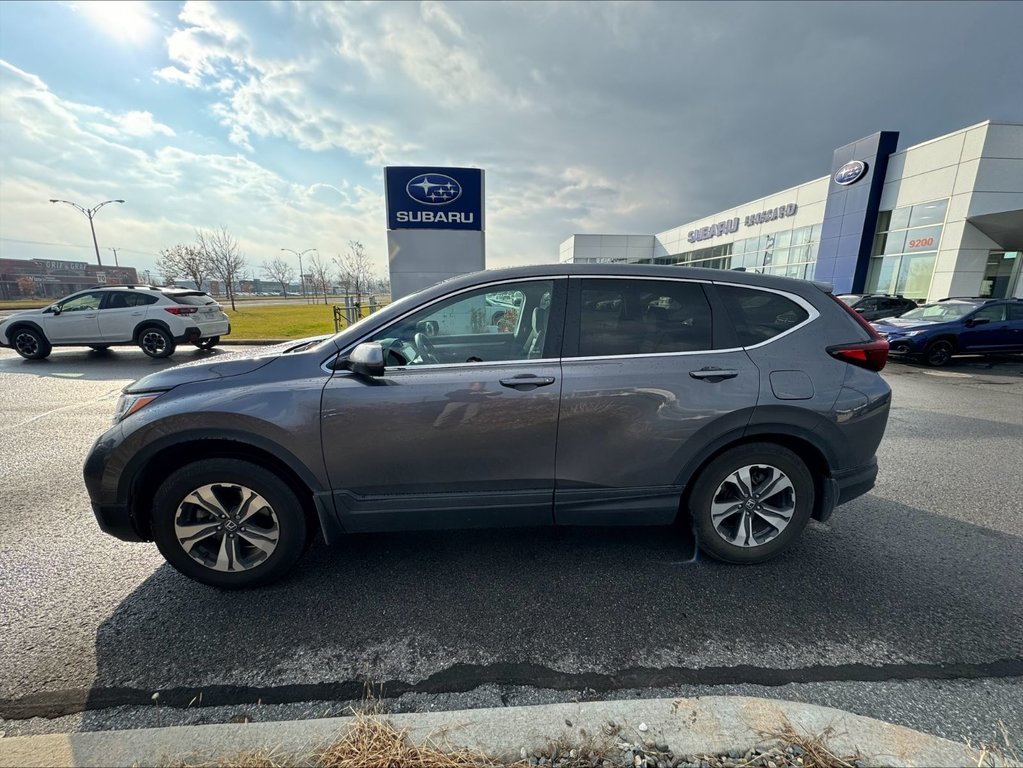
[152, 459, 308, 589]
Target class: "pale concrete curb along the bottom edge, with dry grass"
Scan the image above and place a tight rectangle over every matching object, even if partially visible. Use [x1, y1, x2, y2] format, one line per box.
[0, 696, 1013, 768]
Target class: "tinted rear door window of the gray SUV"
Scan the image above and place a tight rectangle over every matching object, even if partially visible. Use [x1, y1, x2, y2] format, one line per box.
[578, 279, 712, 357]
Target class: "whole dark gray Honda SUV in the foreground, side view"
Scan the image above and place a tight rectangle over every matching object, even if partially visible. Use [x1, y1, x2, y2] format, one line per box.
[85, 265, 891, 587]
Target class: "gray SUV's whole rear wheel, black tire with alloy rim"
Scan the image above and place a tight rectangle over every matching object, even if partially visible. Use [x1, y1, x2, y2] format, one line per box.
[688, 443, 813, 563]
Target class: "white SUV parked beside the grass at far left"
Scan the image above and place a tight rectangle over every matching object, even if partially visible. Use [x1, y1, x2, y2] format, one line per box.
[0, 285, 231, 360]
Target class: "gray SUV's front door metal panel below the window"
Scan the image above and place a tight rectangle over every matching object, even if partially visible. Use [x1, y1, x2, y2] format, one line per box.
[321, 361, 562, 531]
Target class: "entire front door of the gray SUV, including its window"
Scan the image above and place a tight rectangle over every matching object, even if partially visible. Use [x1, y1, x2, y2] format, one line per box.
[321, 279, 567, 531]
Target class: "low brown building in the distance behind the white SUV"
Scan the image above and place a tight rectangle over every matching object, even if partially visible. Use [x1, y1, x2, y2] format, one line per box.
[0, 259, 138, 300]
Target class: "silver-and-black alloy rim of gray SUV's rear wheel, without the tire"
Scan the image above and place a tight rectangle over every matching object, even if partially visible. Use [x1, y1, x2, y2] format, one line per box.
[711, 464, 796, 547]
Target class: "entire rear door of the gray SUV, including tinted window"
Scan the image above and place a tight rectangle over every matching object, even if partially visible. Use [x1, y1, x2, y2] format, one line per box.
[554, 278, 760, 525]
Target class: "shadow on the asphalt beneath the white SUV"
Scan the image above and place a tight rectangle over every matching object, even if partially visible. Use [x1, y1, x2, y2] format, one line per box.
[0, 346, 239, 381]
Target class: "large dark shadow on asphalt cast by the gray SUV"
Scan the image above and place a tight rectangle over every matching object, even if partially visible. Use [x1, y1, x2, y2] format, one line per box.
[65, 496, 1023, 729]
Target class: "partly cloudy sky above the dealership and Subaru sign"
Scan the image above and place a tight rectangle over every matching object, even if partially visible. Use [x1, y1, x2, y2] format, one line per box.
[0, 0, 1023, 277]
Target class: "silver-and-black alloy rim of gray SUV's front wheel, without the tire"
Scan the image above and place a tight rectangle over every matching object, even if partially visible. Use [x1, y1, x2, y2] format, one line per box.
[174, 483, 280, 573]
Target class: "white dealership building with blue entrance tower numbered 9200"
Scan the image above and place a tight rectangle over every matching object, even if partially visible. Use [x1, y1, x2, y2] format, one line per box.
[560, 121, 1023, 302]
